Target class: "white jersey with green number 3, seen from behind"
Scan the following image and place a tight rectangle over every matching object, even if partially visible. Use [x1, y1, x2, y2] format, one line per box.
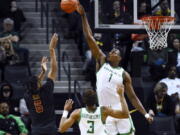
[79, 107, 106, 135]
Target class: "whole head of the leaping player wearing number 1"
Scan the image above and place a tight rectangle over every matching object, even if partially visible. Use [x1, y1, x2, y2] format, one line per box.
[107, 48, 122, 65]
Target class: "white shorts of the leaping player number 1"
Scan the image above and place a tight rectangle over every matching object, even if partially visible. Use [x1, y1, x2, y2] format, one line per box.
[105, 117, 135, 135]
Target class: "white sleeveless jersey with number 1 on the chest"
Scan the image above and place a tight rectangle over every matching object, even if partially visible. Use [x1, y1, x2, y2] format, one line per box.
[96, 63, 124, 109]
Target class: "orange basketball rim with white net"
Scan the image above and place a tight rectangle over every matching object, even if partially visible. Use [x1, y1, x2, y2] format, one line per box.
[141, 16, 175, 50]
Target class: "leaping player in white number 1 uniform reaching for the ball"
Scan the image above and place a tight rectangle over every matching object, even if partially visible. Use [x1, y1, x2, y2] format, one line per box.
[77, 4, 153, 135]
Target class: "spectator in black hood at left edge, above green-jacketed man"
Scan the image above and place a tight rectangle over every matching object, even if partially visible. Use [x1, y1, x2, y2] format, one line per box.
[0, 82, 19, 115]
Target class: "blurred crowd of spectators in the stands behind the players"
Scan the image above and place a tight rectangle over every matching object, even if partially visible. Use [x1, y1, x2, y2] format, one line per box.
[0, 0, 180, 135]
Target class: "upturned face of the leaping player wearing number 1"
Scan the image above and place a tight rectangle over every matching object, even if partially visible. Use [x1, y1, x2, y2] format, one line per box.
[108, 49, 121, 62]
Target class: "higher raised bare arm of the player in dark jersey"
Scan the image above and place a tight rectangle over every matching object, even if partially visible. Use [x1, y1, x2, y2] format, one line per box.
[48, 33, 58, 80]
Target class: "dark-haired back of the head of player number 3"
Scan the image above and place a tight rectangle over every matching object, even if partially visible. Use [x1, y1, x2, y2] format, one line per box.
[83, 90, 97, 106]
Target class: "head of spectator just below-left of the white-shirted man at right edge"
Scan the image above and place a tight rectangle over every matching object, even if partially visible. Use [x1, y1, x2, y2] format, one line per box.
[154, 82, 167, 99]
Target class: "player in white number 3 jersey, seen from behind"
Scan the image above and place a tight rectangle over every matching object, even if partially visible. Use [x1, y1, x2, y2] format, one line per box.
[59, 85, 129, 135]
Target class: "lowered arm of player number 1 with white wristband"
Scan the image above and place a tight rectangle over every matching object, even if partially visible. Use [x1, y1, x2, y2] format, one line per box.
[123, 72, 153, 123]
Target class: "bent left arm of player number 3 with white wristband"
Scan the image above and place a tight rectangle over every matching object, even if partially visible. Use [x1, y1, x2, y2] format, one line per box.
[58, 99, 80, 133]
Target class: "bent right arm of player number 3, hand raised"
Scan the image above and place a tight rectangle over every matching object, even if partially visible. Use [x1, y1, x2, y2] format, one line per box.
[103, 85, 129, 119]
